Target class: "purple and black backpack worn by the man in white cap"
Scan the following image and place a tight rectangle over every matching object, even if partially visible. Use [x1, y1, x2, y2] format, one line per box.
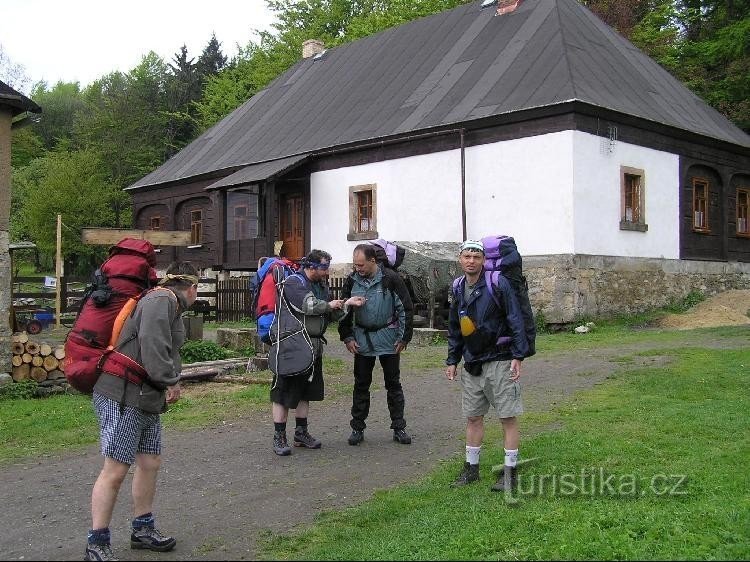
[453, 235, 536, 357]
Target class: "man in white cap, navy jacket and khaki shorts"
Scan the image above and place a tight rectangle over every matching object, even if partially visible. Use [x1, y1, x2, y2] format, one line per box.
[445, 239, 534, 491]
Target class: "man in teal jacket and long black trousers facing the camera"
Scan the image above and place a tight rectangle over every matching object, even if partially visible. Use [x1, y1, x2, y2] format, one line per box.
[339, 244, 414, 445]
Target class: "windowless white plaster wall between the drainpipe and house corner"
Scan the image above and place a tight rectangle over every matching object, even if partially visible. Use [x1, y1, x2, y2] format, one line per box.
[466, 131, 574, 255]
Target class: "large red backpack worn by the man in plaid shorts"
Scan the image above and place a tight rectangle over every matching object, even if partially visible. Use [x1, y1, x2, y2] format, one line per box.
[63, 238, 157, 393]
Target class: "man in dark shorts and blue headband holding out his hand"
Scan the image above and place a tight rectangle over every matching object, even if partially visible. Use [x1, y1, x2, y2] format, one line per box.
[269, 250, 368, 456]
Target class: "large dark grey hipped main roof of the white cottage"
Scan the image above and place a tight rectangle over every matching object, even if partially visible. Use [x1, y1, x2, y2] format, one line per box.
[131, 0, 750, 188]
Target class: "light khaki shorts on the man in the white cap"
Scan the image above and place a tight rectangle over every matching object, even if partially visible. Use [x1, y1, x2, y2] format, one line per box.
[461, 361, 523, 418]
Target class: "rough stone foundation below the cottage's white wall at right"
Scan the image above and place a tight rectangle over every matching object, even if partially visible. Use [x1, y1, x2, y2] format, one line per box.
[523, 255, 750, 324]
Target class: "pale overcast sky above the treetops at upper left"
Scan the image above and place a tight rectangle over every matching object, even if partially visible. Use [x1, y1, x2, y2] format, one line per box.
[0, 0, 273, 93]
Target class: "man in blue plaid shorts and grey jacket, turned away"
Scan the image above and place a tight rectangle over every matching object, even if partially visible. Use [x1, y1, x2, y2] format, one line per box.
[84, 262, 199, 560]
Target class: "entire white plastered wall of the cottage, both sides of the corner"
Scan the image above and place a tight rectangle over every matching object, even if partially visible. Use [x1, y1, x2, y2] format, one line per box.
[310, 131, 679, 263]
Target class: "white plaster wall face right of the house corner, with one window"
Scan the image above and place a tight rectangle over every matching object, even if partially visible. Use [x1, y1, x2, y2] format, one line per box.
[573, 131, 680, 259]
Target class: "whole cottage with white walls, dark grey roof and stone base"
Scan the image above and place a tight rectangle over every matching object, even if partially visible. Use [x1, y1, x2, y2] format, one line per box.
[128, 0, 750, 323]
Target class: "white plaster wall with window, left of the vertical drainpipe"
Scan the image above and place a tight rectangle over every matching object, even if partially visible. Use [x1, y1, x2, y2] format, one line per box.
[310, 150, 461, 262]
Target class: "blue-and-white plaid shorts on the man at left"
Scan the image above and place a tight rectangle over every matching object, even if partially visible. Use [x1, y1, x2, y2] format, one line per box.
[93, 393, 161, 465]
